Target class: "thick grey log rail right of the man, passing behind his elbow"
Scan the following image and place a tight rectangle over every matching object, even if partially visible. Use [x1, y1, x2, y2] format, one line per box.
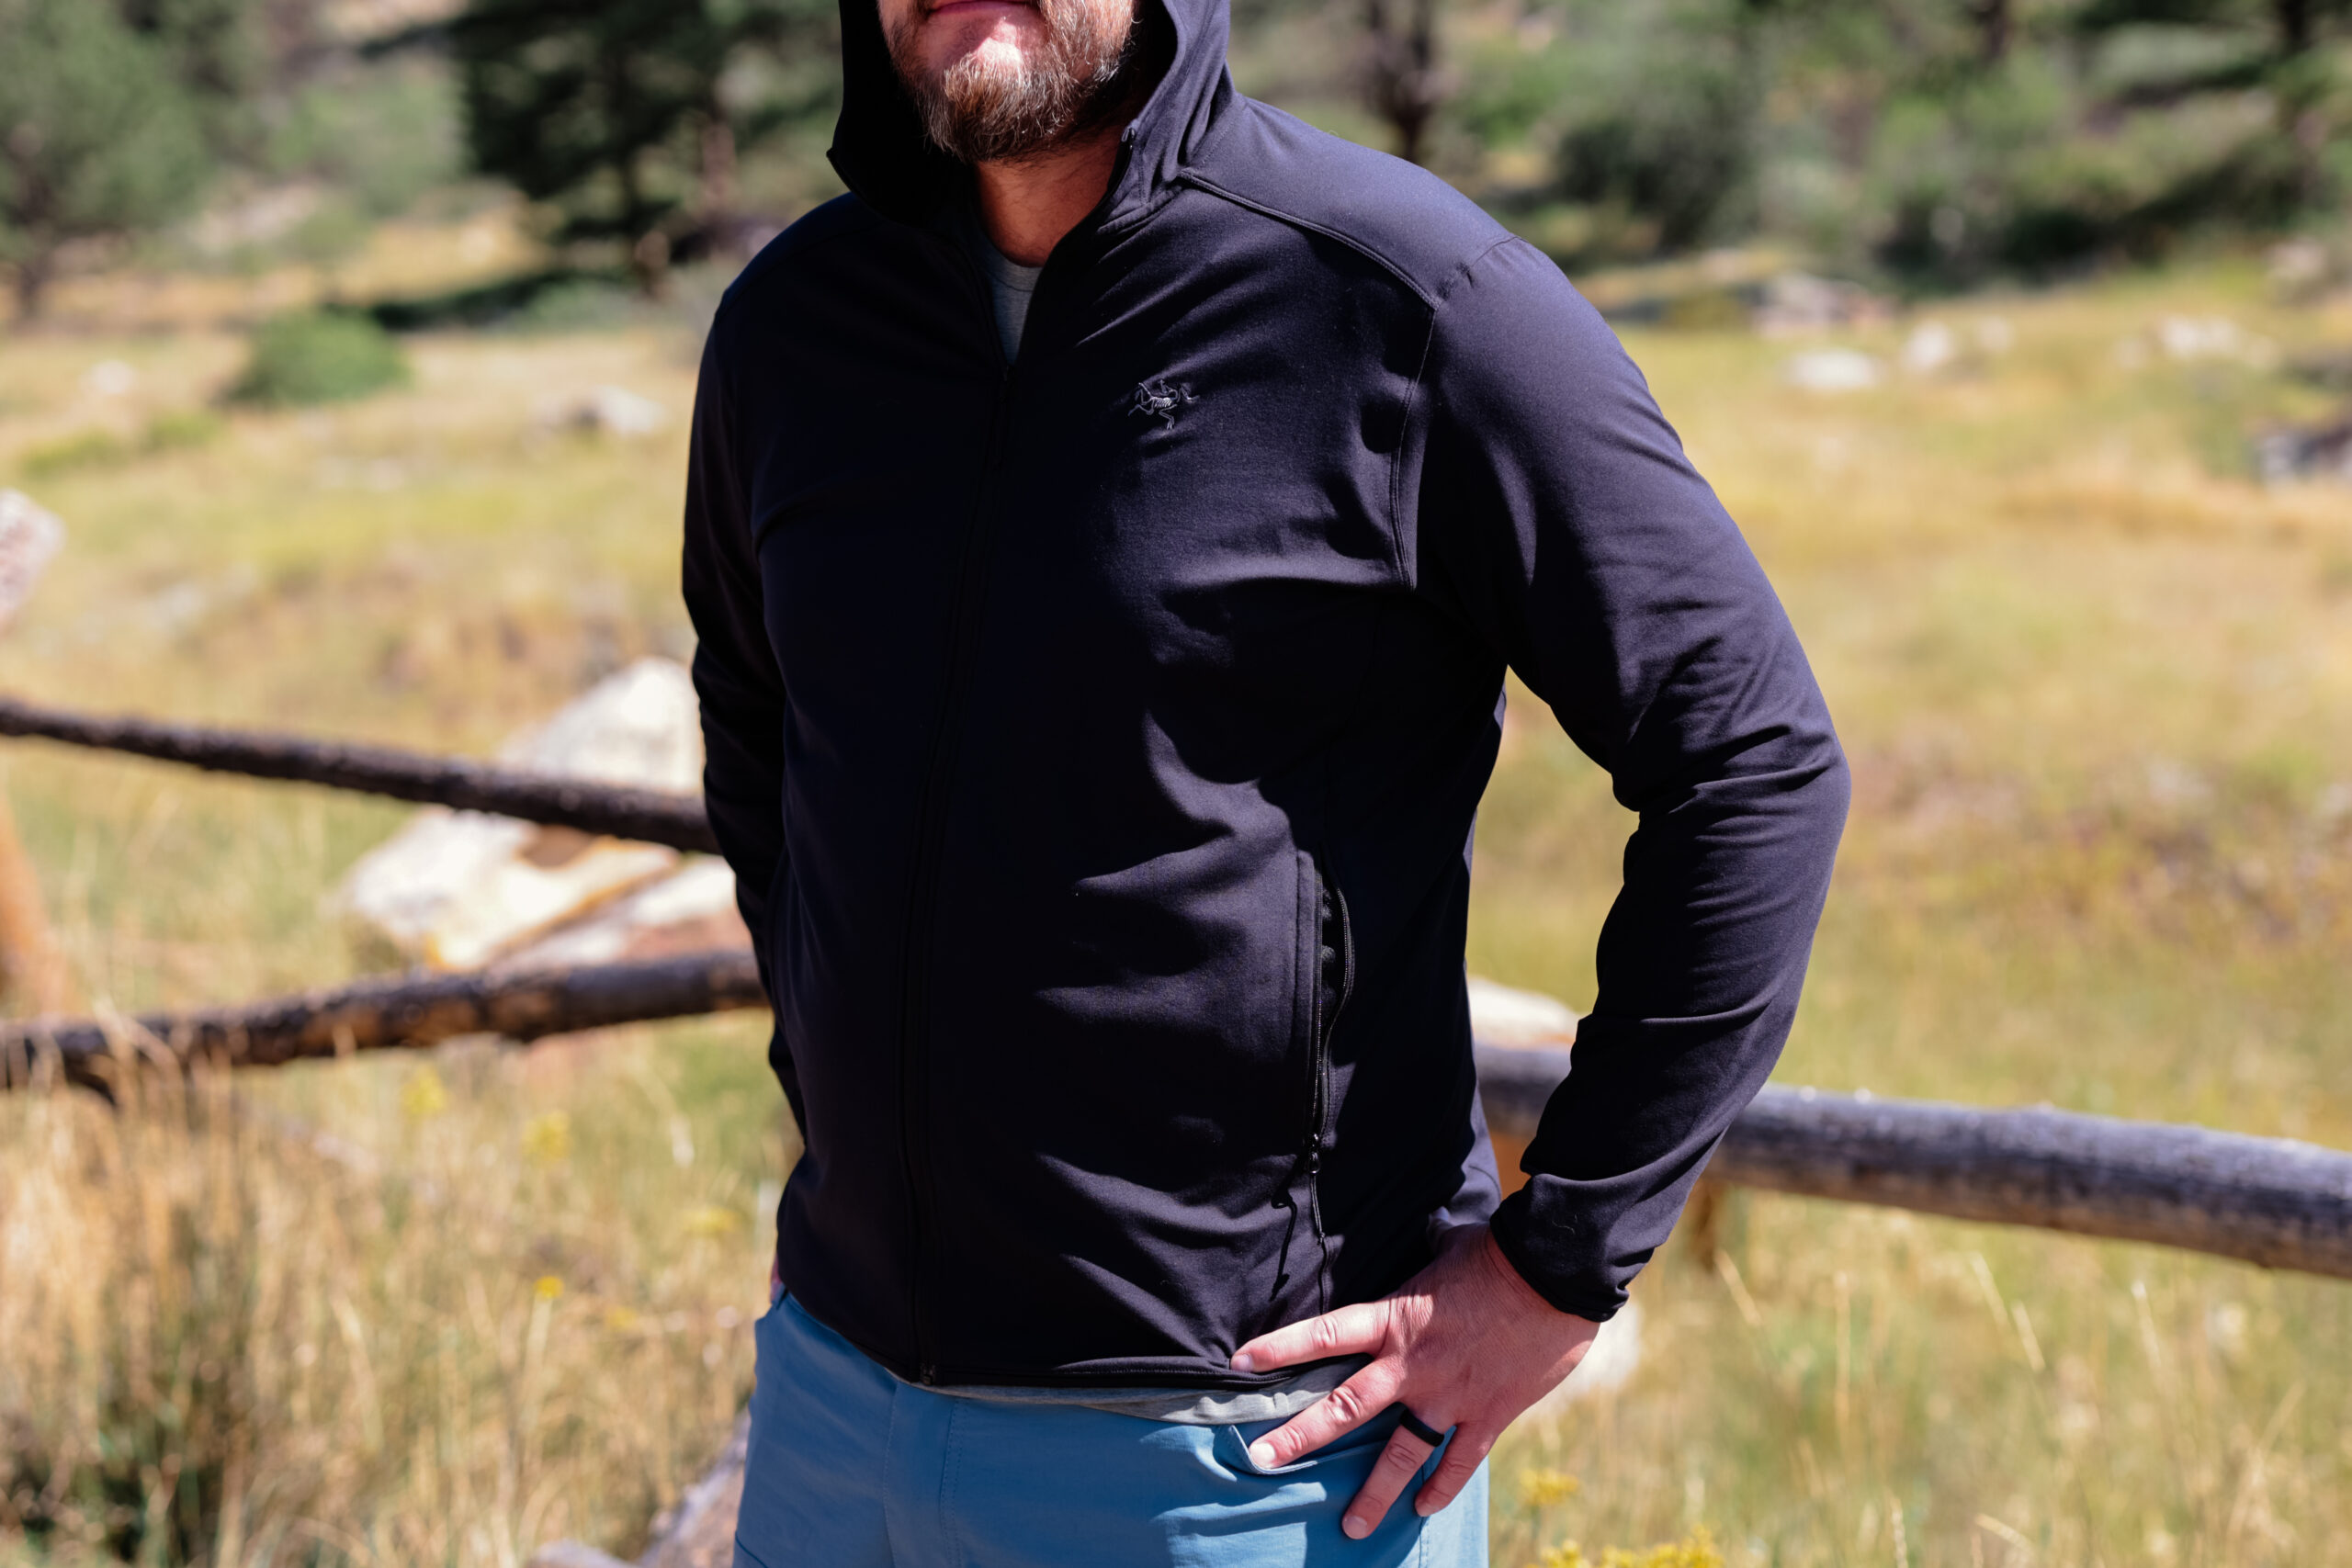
[1477, 1046, 2352, 1279]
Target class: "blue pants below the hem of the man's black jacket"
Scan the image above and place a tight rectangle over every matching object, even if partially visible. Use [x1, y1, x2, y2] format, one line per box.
[734, 1298, 1487, 1568]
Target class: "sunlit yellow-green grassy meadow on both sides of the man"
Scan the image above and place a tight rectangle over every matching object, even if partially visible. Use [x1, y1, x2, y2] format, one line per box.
[0, 231, 2352, 1568]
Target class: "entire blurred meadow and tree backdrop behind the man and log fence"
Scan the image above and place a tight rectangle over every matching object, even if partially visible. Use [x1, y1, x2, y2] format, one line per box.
[0, 0, 2352, 1568]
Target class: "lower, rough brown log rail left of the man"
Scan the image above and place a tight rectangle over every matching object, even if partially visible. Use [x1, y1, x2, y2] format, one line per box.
[0, 950, 767, 1093]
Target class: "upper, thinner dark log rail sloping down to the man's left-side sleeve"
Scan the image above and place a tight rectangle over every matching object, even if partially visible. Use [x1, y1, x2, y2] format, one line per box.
[0, 698, 718, 851]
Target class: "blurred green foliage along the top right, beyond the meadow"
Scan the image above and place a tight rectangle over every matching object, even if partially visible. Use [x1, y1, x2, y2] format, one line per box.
[1446, 0, 2352, 287]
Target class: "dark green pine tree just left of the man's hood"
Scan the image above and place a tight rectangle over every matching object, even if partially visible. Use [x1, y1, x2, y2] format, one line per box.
[449, 0, 835, 289]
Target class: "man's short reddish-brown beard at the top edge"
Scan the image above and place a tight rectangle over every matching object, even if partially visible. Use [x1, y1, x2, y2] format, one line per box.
[889, 0, 1150, 164]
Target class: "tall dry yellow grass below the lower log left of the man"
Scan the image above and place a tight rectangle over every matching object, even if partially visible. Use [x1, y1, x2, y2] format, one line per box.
[0, 1032, 783, 1568]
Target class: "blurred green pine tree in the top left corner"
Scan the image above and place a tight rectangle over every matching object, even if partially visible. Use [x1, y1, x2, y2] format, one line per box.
[0, 0, 209, 320]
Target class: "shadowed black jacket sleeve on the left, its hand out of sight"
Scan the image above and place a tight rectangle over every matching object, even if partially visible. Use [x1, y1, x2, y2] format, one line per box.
[684, 331, 807, 1131]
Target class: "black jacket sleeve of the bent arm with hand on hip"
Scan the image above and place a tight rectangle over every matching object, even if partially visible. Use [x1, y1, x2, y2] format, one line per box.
[1416, 240, 1849, 1319]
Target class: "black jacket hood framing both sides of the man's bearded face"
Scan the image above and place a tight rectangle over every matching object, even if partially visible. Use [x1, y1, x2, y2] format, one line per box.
[828, 0, 1232, 226]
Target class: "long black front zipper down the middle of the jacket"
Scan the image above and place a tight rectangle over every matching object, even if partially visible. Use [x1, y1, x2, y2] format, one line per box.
[899, 256, 1013, 1384]
